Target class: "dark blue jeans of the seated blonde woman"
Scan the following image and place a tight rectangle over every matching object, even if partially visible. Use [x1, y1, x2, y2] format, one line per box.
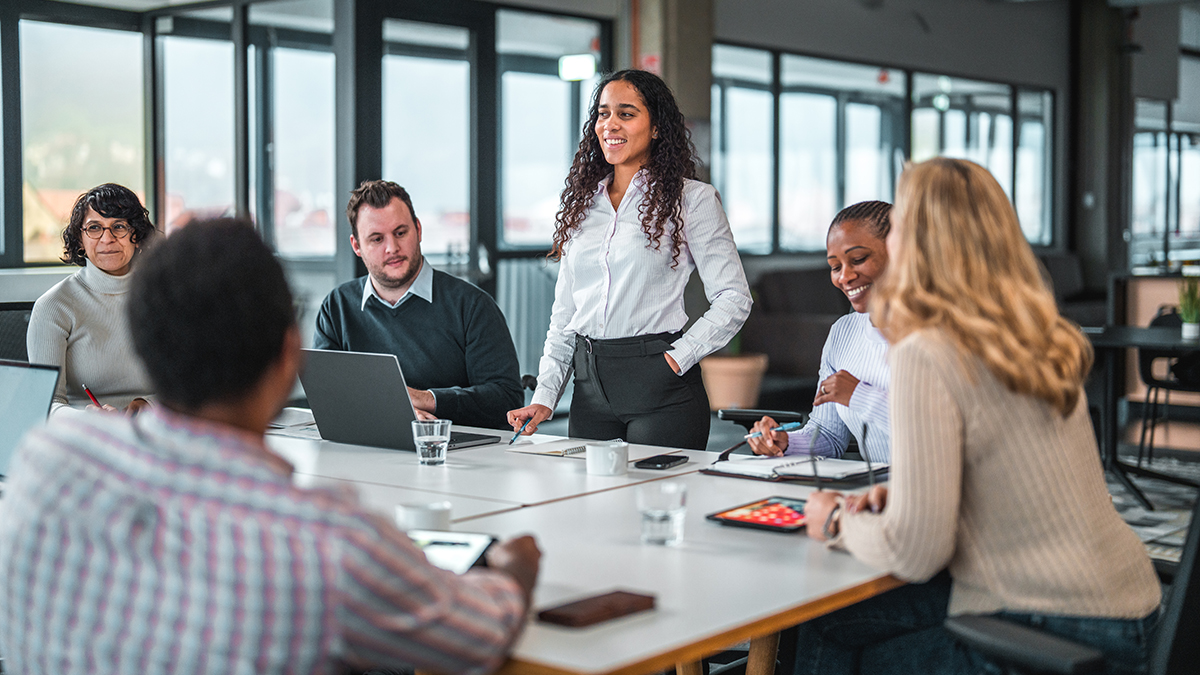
[794, 572, 1158, 675]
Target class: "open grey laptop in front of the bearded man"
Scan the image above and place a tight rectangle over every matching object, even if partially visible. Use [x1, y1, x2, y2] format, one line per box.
[300, 350, 500, 452]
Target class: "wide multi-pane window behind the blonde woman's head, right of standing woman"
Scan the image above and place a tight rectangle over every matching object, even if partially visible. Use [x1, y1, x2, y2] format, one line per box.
[712, 44, 1054, 253]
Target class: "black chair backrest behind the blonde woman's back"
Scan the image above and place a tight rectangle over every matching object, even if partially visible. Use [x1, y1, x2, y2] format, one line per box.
[1150, 487, 1200, 675]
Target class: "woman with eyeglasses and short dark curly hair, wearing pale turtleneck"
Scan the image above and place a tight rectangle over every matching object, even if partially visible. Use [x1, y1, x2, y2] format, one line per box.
[26, 183, 157, 414]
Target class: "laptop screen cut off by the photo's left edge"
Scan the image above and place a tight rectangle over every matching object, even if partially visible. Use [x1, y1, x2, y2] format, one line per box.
[0, 360, 59, 478]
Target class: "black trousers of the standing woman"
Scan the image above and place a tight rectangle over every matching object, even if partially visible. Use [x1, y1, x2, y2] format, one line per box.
[569, 333, 709, 450]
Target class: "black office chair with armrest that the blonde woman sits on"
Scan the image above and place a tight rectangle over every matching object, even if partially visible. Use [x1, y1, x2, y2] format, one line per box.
[946, 487, 1200, 675]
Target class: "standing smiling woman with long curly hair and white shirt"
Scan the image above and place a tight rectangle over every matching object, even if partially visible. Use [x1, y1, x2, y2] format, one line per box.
[509, 71, 750, 449]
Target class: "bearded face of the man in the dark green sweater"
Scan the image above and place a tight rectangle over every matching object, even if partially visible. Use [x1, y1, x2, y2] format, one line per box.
[350, 197, 421, 299]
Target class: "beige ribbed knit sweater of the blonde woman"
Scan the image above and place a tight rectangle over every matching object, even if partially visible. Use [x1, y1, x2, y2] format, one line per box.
[838, 330, 1160, 619]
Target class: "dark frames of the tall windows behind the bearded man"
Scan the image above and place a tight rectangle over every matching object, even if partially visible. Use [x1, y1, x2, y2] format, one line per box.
[0, 0, 613, 282]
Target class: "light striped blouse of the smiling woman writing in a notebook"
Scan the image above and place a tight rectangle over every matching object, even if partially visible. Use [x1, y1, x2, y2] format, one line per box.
[785, 312, 892, 461]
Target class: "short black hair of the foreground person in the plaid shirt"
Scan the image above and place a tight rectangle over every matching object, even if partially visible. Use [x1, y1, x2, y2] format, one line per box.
[128, 219, 295, 411]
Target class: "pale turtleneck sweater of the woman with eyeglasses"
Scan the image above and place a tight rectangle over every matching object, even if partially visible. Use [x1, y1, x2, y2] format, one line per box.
[25, 264, 151, 414]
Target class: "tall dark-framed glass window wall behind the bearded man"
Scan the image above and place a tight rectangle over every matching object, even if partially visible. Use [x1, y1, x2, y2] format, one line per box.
[0, 0, 612, 270]
